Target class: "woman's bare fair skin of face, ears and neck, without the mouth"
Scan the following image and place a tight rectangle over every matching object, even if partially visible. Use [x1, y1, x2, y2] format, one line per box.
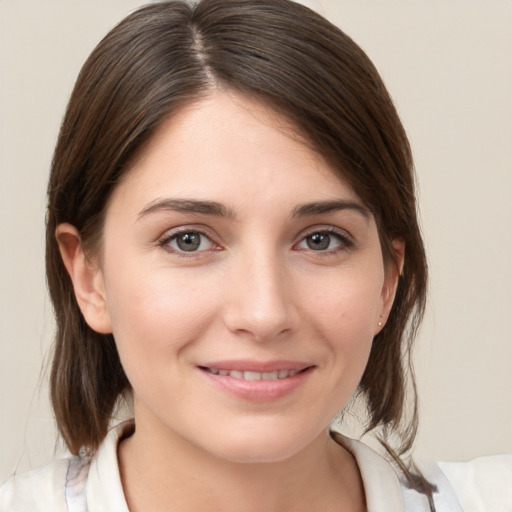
[57, 91, 403, 512]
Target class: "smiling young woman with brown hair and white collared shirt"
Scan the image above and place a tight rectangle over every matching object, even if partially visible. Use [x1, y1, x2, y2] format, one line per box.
[0, 0, 510, 512]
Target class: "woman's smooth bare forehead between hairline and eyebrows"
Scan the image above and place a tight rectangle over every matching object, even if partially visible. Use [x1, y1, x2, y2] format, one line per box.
[110, 92, 357, 217]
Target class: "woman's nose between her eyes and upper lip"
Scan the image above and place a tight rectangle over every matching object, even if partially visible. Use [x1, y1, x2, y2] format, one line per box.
[224, 249, 299, 342]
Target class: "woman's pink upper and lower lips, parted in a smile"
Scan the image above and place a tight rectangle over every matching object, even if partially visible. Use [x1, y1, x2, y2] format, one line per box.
[198, 360, 314, 402]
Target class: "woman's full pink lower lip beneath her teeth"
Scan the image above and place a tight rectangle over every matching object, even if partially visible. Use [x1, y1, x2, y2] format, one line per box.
[200, 367, 313, 402]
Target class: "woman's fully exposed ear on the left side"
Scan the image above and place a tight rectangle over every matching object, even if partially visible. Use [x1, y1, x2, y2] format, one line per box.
[55, 224, 112, 334]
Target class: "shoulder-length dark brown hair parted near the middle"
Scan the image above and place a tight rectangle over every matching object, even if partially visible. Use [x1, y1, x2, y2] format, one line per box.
[46, 0, 431, 504]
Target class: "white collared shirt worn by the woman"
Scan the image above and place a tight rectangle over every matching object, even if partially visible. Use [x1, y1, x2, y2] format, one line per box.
[0, 422, 512, 512]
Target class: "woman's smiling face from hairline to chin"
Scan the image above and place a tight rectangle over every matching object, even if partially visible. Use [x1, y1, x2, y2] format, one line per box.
[90, 92, 396, 462]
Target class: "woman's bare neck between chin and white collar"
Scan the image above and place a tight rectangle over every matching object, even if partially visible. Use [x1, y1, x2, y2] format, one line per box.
[118, 418, 364, 512]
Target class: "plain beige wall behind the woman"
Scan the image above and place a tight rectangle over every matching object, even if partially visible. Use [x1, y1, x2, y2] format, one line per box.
[0, 0, 512, 480]
